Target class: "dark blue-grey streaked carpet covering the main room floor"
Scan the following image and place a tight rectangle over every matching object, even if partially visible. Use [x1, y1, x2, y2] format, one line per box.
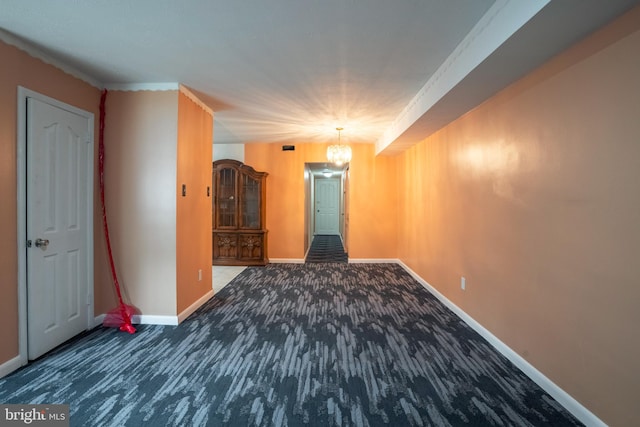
[0, 264, 580, 426]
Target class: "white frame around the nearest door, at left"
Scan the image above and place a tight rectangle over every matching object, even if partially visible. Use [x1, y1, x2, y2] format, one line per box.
[16, 86, 95, 366]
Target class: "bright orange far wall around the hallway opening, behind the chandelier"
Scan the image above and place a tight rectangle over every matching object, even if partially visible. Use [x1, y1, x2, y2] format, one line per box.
[245, 143, 397, 259]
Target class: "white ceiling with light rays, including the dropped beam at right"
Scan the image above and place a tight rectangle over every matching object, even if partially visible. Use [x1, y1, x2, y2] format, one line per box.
[0, 0, 640, 153]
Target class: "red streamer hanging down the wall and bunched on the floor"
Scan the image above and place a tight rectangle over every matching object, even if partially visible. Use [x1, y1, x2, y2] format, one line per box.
[98, 89, 137, 334]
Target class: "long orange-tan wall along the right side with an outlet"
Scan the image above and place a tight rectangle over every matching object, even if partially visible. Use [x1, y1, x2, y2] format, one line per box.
[397, 10, 640, 426]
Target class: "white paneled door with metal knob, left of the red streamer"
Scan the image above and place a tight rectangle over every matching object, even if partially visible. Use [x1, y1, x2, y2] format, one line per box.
[26, 98, 93, 359]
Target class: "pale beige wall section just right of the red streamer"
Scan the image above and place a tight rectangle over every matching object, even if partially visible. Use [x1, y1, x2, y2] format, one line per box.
[105, 91, 178, 316]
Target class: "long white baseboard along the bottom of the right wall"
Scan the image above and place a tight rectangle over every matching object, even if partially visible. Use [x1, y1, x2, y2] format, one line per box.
[397, 260, 607, 427]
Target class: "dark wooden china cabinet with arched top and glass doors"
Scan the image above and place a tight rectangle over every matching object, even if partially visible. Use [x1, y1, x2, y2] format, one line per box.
[213, 159, 269, 265]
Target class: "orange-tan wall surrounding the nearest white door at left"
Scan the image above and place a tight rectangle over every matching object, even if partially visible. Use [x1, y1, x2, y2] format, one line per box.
[0, 42, 104, 364]
